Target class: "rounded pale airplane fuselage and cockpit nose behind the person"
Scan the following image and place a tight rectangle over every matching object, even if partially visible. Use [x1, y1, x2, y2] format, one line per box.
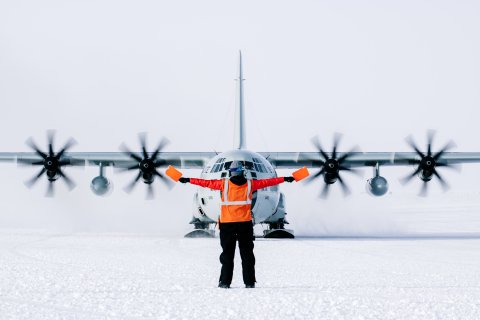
[194, 150, 280, 223]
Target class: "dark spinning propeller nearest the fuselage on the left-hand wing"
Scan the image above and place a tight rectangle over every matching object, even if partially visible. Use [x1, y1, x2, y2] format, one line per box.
[120, 133, 173, 200]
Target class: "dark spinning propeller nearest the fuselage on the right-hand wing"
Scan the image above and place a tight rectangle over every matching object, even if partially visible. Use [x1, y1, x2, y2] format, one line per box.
[307, 133, 359, 199]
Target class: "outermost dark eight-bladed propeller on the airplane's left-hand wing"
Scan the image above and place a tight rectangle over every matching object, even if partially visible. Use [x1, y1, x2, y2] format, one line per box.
[18, 130, 79, 197]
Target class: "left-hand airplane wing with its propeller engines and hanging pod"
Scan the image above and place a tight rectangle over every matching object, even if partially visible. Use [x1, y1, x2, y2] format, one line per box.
[0, 151, 216, 199]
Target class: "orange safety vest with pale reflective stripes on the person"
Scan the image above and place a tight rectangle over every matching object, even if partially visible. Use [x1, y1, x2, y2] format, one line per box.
[220, 179, 253, 222]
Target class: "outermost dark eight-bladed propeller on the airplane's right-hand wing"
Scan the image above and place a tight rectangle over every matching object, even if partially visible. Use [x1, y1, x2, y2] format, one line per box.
[400, 130, 458, 197]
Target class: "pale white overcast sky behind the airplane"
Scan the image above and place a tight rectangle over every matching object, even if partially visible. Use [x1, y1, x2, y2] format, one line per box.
[0, 0, 480, 234]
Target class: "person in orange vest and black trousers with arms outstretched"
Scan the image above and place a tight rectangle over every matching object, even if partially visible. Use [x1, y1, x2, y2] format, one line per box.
[179, 161, 295, 288]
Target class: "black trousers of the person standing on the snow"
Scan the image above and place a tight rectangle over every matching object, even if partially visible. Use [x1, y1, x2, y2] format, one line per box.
[220, 221, 256, 285]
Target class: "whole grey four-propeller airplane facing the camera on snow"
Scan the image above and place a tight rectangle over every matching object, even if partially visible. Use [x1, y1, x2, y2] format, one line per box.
[0, 52, 480, 238]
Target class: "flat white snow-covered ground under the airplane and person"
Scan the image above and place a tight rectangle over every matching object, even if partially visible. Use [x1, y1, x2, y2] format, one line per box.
[0, 230, 480, 319]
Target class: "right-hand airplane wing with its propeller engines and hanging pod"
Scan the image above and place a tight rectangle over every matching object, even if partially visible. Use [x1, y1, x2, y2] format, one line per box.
[258, 147, 480, 198]
